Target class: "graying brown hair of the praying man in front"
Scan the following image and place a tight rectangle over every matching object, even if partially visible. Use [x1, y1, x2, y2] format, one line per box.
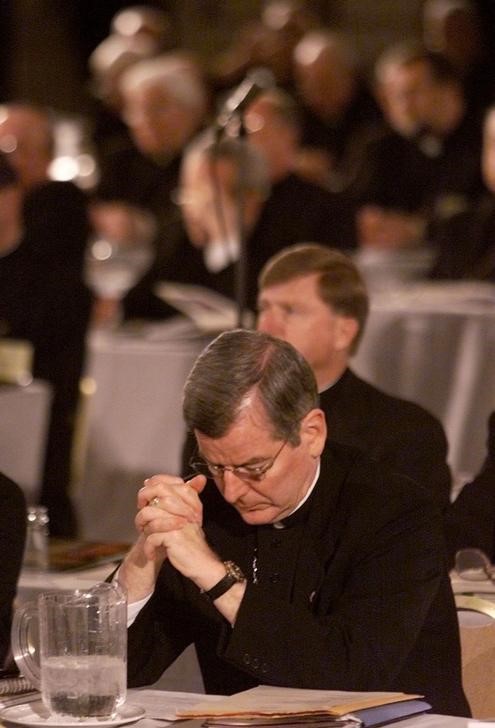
[183, 329, 318, 445]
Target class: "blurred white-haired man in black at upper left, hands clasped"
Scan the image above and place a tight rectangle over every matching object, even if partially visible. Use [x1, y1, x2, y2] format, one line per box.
[92, 53, 208, 264]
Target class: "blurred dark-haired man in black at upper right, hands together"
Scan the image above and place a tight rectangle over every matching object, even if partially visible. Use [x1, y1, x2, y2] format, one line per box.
[353, 43, 481, 249]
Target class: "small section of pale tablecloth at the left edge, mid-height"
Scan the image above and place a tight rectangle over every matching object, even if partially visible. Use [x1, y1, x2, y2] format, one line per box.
[0, 380, 51, 502]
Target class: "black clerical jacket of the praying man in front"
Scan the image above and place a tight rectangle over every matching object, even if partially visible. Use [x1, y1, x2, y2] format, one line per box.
[129, 444, 469, 715]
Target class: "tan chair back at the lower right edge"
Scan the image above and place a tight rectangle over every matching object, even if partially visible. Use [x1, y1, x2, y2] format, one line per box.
[455, 595, 495, 719]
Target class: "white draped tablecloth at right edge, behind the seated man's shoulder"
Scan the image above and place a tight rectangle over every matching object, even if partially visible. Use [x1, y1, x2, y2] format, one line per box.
[353, 283, 495, 474]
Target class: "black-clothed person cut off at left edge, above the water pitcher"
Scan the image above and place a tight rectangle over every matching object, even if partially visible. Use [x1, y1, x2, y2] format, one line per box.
[0, 473, 26, 669]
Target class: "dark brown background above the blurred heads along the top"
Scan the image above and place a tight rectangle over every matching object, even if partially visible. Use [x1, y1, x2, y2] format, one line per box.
[0, 0, 495, 113]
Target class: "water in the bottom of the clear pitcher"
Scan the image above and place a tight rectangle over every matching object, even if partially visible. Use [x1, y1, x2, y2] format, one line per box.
[41, 655, 126, 718]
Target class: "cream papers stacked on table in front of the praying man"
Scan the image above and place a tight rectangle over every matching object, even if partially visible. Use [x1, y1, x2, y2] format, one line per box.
[177, 685, 422, 719]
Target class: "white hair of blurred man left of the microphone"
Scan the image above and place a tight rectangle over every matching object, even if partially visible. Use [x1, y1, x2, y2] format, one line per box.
[119, 53, 208, 111]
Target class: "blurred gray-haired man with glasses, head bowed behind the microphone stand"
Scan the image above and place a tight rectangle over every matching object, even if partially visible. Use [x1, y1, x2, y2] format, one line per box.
[124, 128, 354, 318]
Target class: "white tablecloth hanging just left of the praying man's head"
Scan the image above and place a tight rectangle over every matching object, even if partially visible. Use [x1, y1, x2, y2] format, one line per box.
[74, 320, 211, 542]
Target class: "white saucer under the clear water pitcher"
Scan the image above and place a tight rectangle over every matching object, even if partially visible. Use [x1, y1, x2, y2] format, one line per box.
[0, 700, 145, 728]
